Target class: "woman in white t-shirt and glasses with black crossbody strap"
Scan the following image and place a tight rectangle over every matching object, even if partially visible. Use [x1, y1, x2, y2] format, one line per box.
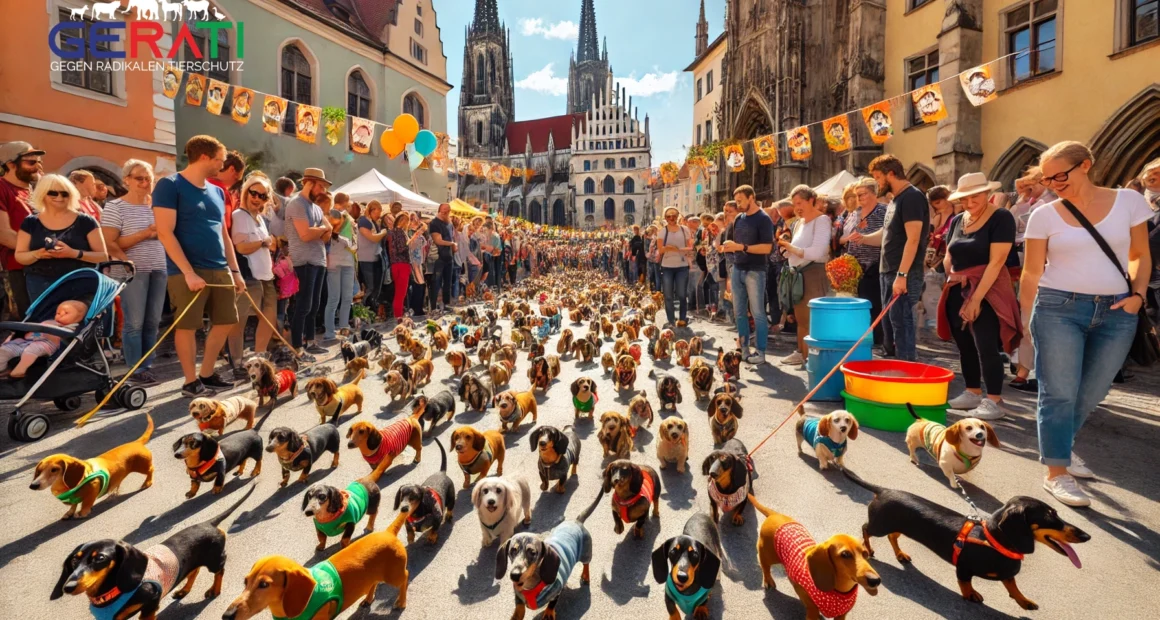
[1020, 142, 1152, 506]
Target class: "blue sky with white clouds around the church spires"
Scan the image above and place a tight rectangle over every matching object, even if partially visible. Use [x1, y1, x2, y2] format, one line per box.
[433, 0, 725, 165]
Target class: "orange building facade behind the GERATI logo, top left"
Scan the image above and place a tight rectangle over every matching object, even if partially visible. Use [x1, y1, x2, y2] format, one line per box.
[0, 0, 175, 187]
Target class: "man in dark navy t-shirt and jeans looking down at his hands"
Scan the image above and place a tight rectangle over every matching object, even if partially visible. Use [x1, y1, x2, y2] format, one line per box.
[722, 185, 774, 365]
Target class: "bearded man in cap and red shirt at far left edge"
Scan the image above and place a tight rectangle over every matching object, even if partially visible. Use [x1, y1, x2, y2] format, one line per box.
[0, 142, 44, 319]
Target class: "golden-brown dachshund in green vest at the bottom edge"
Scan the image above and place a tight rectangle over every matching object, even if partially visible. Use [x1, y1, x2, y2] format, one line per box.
[222, 512, 409, 620]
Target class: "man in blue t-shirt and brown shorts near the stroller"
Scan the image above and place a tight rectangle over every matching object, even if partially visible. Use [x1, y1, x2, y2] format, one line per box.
[153, 136, 246, 398]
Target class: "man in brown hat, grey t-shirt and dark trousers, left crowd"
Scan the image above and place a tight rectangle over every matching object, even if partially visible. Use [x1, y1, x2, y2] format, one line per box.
[285, 168, 333, 362]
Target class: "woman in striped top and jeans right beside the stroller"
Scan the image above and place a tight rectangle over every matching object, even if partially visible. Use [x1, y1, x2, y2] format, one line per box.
[101, 159, 167, 385]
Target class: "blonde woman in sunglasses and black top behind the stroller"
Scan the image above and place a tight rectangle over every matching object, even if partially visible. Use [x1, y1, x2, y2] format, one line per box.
[16, 174, 109, 300]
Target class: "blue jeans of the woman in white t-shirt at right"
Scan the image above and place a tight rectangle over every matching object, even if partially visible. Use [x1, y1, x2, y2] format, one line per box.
[1031, 287, 1138, 467]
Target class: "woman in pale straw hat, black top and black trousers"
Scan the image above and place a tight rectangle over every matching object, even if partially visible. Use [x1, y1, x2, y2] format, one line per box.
[937, 172, 1023, 420]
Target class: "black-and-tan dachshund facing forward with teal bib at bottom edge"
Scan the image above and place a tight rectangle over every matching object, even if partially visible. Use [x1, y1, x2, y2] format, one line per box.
[653, 512, 725, 620]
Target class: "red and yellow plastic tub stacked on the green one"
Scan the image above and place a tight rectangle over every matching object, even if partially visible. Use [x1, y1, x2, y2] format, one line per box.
[842, 360, 955, 406]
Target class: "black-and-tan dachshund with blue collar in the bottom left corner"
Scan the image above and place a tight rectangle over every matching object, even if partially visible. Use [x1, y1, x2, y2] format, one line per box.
[49, 485, 254, 620]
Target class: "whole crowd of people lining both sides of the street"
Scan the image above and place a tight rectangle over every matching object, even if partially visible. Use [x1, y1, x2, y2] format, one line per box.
[0, 136, 1160, 505]
